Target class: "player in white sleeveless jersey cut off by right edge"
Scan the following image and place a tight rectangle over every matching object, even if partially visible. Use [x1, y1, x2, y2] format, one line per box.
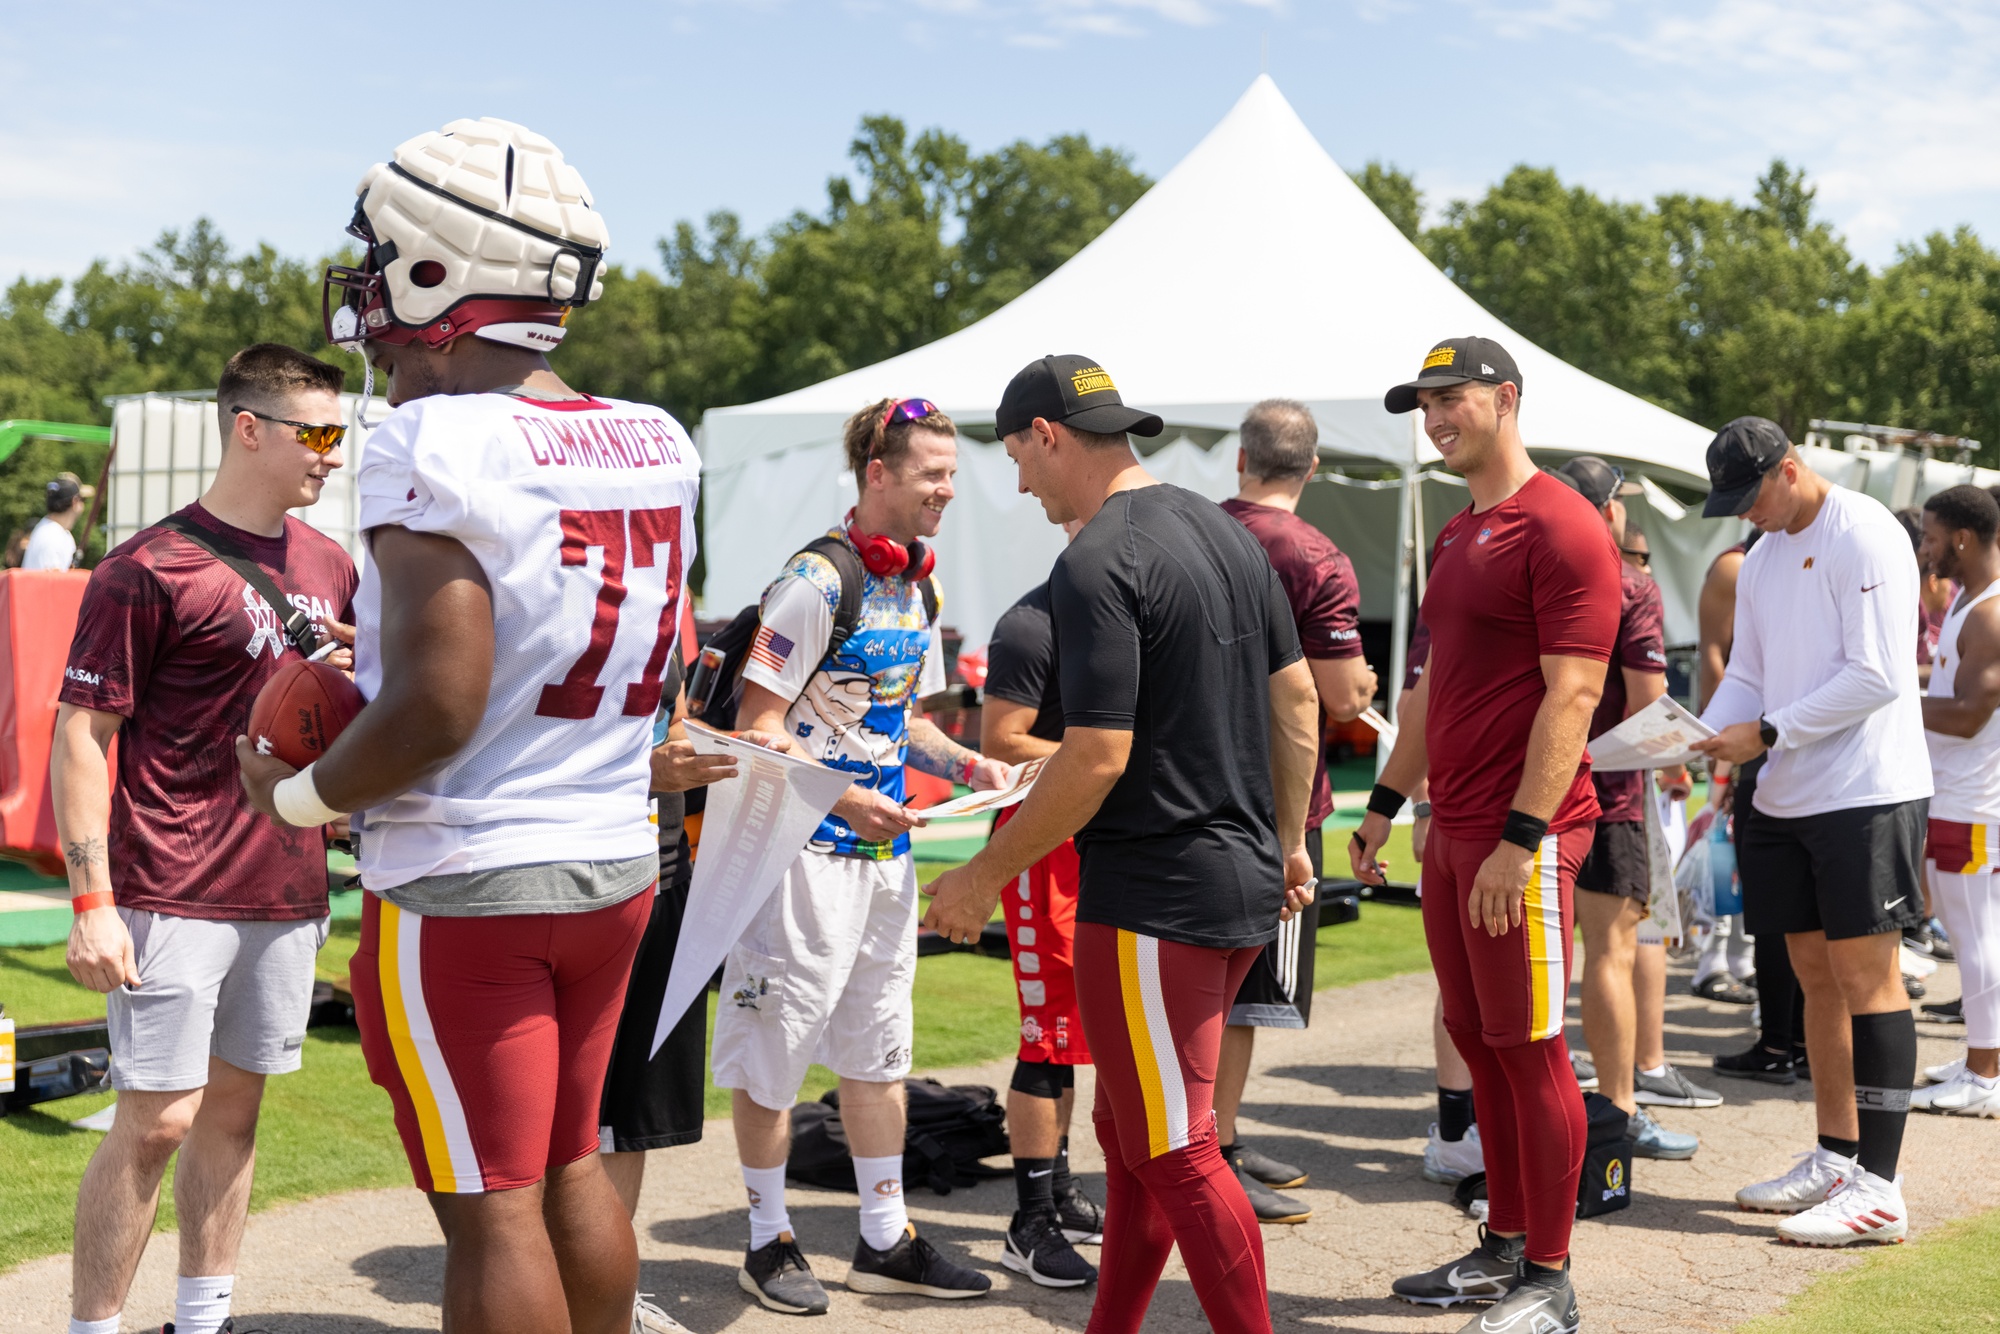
[1910, 486, 2000, 1116]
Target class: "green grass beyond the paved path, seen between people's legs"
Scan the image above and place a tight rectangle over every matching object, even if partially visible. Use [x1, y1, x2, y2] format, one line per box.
[0, 892, 1428, 1270]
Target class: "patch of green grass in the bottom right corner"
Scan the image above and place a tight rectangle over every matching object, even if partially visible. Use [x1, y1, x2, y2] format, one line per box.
[1742, 1210, 2000, 1334]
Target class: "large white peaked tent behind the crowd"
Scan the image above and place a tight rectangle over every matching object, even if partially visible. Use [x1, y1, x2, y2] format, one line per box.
[702, 76, 1732, 668]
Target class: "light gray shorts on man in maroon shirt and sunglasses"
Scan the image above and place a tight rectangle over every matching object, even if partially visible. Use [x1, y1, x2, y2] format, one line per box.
[106, 908, 326, 1094]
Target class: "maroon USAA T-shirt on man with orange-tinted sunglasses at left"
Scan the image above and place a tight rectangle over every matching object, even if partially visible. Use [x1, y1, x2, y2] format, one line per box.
[60, 502, 356, 922]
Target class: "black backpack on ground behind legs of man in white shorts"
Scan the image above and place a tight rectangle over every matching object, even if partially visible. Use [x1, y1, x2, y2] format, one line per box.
[784, 1080, 1012, 1196]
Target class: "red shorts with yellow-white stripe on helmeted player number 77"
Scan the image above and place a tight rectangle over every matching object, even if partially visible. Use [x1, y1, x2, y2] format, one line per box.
[352, 890, 654, 1194]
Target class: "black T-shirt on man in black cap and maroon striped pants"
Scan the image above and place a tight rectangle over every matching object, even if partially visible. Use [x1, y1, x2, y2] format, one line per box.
[1048, 486, 1300, 950]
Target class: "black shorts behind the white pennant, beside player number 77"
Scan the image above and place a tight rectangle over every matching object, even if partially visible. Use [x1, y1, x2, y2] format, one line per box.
[598, 844, 708, 1154]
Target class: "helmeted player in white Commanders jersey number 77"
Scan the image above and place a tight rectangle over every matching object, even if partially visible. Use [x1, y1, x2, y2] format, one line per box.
[238, 120, 700, 1334]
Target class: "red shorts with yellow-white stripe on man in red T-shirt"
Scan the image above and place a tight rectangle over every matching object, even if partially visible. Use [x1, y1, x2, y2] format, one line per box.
[1424, 824, 1592, 1046]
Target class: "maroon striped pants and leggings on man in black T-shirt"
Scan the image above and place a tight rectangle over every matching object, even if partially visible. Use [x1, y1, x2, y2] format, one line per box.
[1076, 922, 1270, 1334]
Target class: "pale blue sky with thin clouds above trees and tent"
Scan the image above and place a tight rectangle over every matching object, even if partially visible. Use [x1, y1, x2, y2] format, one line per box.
[0, 0, 2000, 280]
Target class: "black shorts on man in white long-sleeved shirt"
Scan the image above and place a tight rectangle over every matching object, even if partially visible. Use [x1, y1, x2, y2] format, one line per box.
[1736, 798, 1930, 940]
